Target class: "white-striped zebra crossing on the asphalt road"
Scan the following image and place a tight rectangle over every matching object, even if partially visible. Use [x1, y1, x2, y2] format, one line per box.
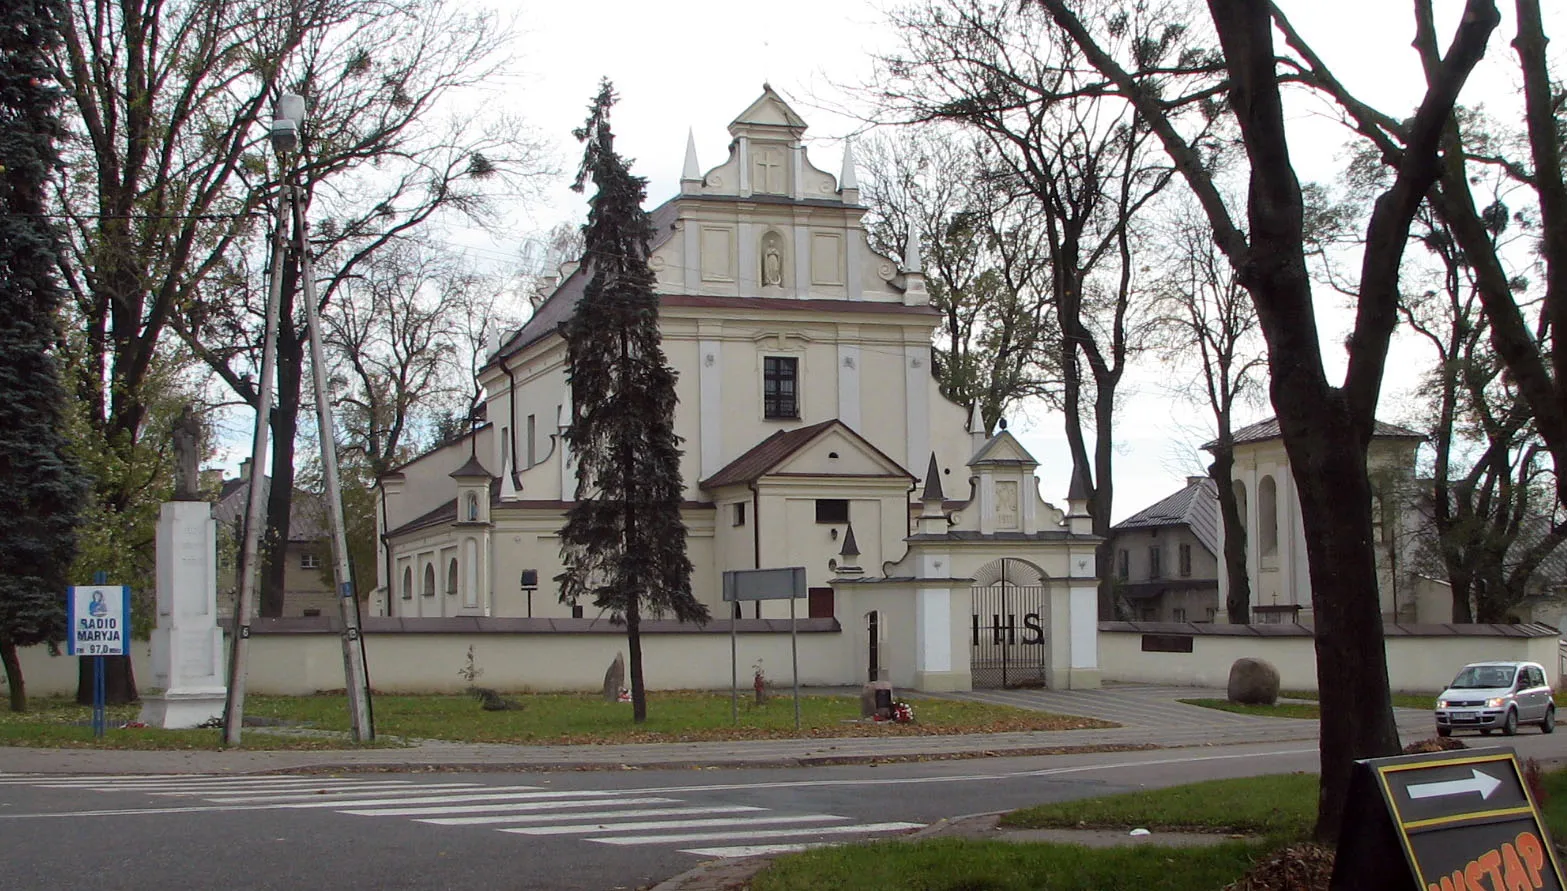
[0, 774, 925, 858]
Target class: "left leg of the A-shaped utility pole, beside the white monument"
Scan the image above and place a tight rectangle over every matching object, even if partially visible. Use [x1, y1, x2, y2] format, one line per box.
[223, 180, 291, 745]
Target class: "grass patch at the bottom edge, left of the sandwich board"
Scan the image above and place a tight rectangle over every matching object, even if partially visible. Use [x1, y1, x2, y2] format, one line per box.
[751, 838, 1261, 891]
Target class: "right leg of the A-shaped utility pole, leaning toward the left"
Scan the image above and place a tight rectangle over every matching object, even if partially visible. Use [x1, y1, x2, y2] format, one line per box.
[291, 185, 376, 742]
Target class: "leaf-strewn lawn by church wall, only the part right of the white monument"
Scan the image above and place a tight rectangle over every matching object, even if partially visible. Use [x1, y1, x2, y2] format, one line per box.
[246, 692, 1114, 745]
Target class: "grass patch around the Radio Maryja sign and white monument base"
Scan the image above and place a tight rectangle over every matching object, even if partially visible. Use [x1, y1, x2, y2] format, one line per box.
[0, 697, 390, 750]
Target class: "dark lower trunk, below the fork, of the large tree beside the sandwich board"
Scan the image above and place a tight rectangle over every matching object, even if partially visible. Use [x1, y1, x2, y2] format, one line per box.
[1285, 407, 1399, 844]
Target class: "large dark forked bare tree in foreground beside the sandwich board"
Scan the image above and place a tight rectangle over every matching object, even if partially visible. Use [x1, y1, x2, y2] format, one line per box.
[1039, 0, 1500, 841]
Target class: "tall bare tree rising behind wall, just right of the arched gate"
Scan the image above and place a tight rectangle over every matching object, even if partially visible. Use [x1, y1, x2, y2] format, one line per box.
[870, 0, 1189, 619]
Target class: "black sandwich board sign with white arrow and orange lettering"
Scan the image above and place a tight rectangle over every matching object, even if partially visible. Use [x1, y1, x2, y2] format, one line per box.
[1329, 749, 1564, 891]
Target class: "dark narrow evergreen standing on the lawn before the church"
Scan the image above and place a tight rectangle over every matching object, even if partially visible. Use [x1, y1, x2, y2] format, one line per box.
[559, 80, 708, 723]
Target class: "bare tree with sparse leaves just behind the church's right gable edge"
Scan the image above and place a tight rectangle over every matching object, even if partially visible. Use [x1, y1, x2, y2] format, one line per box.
[859, 125, 1059, 432]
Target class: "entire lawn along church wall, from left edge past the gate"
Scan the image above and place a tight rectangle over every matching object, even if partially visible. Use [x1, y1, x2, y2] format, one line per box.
[0, 692, 1116, 749]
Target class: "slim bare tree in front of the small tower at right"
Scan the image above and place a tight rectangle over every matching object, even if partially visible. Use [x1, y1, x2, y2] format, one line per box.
[1155, 202, 1268, 625]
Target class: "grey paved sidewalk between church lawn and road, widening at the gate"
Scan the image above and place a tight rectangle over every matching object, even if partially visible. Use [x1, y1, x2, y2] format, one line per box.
[0, 686, 1431, 774]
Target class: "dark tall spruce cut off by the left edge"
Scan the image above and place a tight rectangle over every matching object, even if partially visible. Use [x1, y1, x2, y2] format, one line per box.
[0, 0, 85, 711]
